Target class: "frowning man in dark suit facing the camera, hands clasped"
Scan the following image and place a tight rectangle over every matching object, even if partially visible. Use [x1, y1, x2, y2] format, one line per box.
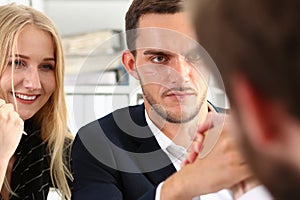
[72, 0, 272, 200]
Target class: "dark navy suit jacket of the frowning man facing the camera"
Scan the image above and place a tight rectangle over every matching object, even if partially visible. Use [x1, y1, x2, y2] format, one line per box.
[72, 105, 176, 200]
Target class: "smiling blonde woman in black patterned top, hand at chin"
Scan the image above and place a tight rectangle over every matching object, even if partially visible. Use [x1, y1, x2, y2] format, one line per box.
[0, 4, 72, 200]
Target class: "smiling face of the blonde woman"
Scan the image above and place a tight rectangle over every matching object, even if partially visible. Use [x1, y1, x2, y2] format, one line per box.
[0, 25, 55, 120]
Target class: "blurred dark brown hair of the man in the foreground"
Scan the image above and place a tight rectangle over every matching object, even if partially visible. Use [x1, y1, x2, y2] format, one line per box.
[191, 0, 300, 119]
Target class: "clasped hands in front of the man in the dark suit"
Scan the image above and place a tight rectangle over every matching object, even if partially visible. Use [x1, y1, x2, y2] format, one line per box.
[161, 113, 252, 199]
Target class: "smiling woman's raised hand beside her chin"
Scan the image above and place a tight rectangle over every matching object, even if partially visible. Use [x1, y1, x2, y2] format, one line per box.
[0, 99, 24, 160]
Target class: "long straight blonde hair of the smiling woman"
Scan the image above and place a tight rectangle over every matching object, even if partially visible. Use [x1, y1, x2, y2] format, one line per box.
[0, 3, 73, 199]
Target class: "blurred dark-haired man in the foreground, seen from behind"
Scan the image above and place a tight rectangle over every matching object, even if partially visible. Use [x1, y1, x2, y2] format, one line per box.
[192, 0, 300, 199]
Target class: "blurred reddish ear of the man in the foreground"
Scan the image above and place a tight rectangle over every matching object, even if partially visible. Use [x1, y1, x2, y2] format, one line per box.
[231, 74, 281, 148]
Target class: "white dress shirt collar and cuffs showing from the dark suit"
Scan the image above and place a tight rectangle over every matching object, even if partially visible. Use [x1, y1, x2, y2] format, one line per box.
[145, 111, 273, 200]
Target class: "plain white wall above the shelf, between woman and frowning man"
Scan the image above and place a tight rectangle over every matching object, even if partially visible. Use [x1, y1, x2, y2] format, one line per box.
[43, 0, 129, 36]
